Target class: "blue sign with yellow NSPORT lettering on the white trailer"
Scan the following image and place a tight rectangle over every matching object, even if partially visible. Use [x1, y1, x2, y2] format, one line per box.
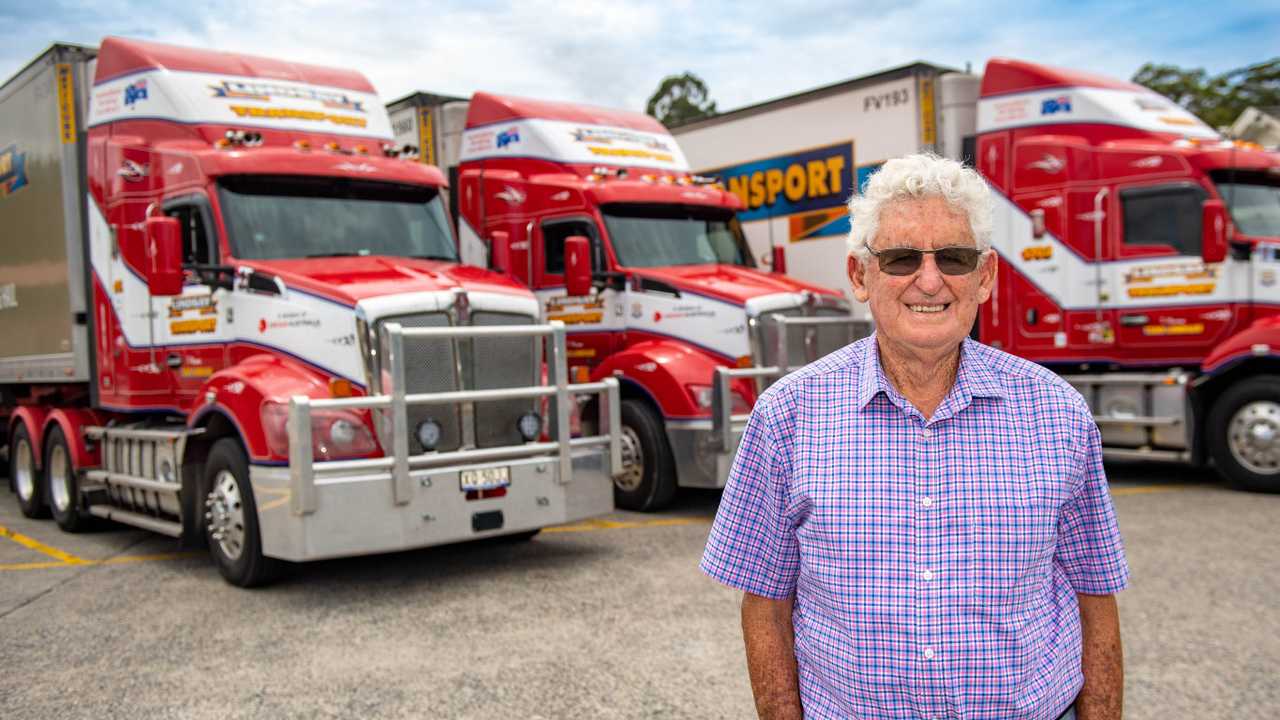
[704, 142, 854, 222]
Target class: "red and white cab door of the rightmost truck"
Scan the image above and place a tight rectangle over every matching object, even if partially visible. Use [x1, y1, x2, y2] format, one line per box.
[1114, 181, 1233, 363]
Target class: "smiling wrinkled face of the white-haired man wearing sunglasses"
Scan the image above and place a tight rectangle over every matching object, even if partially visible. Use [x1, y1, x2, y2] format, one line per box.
[849, 197, 996, 354]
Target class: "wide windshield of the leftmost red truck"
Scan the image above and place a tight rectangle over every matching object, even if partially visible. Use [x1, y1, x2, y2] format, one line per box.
[219, 176, 457, 261]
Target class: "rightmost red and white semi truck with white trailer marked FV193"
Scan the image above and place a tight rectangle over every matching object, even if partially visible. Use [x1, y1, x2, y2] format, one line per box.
[676, 59, 1280, 492]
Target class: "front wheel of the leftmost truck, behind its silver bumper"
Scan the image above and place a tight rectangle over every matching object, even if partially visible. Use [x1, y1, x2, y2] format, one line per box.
[202, 438, 280, 588]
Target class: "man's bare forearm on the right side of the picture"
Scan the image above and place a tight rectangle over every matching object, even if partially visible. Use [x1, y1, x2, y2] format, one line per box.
[1080, 593, 1124, 720]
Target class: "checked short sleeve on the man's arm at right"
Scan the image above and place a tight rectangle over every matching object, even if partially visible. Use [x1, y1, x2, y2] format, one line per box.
[1053, 401, 1129, 594]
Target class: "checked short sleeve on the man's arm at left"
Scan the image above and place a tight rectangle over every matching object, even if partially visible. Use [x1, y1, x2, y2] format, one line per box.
[700, 383, 800, 600]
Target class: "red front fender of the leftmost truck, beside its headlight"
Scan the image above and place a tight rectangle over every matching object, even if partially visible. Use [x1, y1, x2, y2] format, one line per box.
[187, 354, 340, 462]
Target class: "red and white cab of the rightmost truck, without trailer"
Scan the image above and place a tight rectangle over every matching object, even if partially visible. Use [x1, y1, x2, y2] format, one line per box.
[973, 59, 1280, 489]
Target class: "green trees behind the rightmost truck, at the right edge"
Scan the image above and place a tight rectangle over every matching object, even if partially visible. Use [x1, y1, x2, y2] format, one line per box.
[1133, 58, 1280, 127]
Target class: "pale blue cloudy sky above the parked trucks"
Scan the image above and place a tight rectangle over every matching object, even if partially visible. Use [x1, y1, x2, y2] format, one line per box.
[0, 0, 1280, 110]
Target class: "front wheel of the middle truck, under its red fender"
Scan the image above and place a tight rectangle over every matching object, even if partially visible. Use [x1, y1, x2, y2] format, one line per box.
[613, 398, 676, 512]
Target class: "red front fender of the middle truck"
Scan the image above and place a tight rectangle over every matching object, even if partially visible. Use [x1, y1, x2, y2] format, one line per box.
[593, 340, 724, 419]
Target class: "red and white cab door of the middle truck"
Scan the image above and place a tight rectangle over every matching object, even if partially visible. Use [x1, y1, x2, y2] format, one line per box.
[534, 215, 622, 368]
